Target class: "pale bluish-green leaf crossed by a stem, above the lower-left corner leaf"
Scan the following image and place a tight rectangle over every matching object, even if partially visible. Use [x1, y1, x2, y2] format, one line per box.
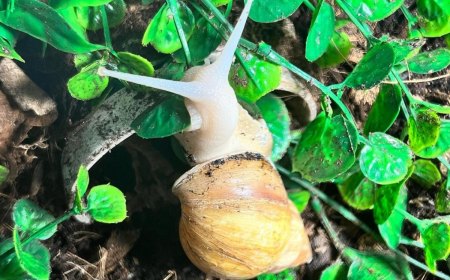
[12, 199, 56, 240]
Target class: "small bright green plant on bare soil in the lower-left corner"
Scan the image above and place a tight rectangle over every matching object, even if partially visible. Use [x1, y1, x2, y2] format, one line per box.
[0, 166, 127, 280]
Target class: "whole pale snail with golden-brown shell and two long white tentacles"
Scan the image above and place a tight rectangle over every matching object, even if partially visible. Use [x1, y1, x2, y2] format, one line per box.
[99, 0, 311, 279]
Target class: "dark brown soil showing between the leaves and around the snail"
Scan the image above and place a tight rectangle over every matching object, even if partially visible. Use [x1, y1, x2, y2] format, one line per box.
[0, 1, 450, 280]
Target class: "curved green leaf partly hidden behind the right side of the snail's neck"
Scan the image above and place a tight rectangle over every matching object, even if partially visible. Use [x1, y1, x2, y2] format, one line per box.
[256, 94, 291, 162]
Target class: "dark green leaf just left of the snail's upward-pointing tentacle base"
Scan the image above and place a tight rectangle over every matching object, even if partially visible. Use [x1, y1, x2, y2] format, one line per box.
[173, 18, 222, 63]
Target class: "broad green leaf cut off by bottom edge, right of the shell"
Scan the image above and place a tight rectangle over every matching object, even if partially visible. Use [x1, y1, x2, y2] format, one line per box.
[344, 248, 414, 280]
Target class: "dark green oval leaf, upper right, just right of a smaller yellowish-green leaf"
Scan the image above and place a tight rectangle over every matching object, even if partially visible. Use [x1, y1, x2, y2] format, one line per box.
[344, 43, 395, 88]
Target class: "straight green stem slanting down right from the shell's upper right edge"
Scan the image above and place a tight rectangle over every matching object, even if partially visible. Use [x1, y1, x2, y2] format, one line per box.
[276, 164, 382, 241]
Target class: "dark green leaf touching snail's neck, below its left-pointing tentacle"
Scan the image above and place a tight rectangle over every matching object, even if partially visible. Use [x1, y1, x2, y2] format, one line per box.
[131, 95, 191, 139]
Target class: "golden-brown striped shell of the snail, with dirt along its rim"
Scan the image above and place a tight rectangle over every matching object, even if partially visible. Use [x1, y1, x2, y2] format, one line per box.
[172, 153, 310, 279]
